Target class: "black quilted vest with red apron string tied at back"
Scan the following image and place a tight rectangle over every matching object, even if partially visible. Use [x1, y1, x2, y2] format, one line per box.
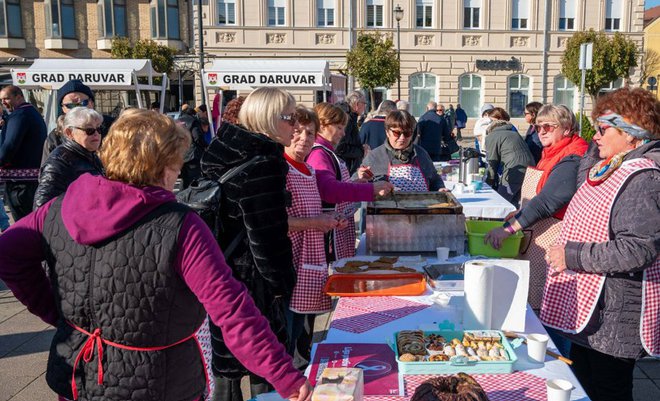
[44, 196, 205, 401]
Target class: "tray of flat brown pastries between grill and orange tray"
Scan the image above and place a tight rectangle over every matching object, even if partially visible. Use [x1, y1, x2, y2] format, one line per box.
[331, 255, 426, 274]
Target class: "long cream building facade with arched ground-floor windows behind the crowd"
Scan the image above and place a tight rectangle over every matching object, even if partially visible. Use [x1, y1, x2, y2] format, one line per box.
[200, 0, 644, 119]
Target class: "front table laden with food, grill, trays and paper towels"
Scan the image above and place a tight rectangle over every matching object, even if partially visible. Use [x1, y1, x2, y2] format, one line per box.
[306, 188, 588, 401]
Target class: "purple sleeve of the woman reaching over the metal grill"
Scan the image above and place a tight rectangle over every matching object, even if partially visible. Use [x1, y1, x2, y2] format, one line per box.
[307, 148, 374, 203]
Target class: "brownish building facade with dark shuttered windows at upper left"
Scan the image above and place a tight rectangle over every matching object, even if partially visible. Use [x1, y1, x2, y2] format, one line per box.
[0, 0, 192, 110]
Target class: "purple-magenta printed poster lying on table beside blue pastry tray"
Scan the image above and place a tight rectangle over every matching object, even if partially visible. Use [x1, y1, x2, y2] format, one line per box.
[309, 344, 399, 395]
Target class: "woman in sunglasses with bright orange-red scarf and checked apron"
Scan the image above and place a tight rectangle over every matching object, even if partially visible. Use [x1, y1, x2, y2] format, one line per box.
[486, 104, 587, 318]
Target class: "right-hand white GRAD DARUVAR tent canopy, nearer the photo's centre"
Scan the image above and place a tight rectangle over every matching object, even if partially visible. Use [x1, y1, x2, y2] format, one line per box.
[202, 59, 330, 90]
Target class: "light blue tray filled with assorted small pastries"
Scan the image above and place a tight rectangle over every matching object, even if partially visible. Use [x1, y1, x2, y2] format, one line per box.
[395, 330, 517, 374]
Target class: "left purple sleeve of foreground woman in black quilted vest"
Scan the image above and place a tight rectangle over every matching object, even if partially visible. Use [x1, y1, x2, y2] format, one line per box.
[0, 199, 59, 325]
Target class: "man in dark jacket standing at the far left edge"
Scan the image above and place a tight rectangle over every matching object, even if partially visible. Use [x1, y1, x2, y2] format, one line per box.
[0, 85, 47, 221]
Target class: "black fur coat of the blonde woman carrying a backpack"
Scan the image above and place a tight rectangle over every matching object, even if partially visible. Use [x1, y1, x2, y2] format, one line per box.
[202, 123, 296, 378]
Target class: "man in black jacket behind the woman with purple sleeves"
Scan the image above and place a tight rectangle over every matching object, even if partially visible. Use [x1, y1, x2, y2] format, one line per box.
[336, 91, 367, 175]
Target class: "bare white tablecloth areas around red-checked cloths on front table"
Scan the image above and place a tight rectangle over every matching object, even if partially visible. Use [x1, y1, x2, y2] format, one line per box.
[312, 290, 589, 401]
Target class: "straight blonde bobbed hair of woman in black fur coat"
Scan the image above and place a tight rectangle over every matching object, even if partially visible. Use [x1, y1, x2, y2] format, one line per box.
[238, 88, 296, 136]
